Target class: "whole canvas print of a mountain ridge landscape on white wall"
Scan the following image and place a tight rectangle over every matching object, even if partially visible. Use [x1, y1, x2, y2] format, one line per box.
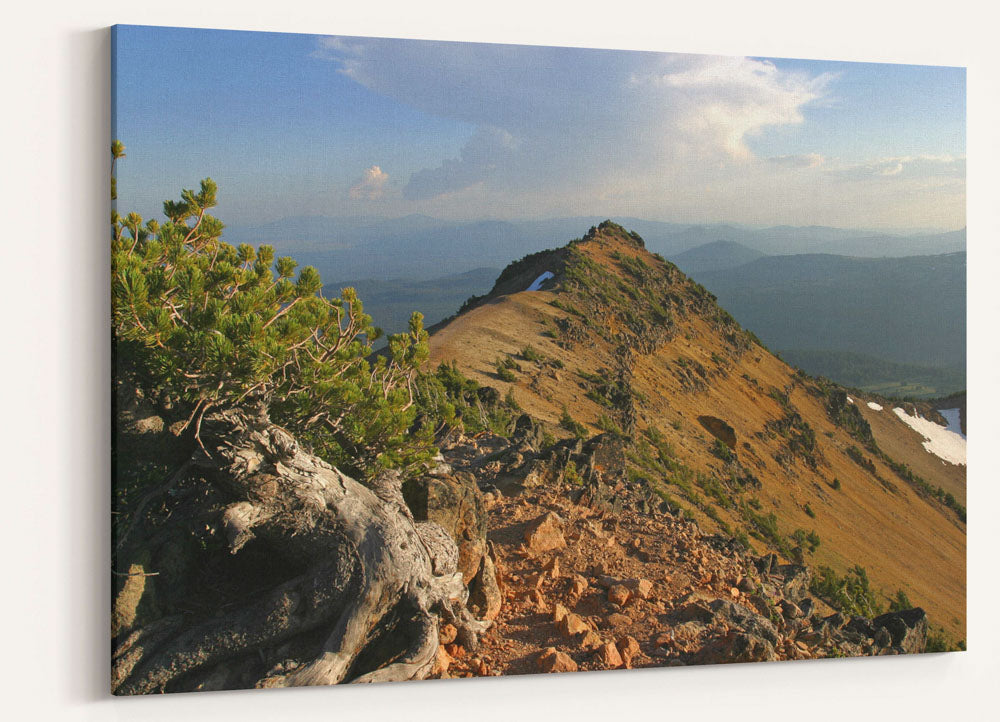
[110, 26, 967, 695]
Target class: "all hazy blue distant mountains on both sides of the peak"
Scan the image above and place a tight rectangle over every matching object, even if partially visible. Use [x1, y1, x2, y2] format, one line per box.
[226, 215, 966, 393]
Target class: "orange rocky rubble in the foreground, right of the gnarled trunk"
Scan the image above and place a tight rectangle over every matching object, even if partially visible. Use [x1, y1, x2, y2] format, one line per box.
[434, 417, 927, 677]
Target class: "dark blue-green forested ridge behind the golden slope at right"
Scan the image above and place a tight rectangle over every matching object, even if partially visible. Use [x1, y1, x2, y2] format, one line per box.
[691, 253, 966, 375]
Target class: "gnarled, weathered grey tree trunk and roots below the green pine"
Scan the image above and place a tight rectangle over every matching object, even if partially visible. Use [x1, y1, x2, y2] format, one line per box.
[111, 404, 487, 694]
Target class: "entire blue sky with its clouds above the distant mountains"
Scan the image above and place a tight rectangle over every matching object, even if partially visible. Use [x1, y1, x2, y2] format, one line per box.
[114, 26, 965, 229]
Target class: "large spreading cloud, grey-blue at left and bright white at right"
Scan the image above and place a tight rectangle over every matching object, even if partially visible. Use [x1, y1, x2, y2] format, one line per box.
[321, 38, 831, 199]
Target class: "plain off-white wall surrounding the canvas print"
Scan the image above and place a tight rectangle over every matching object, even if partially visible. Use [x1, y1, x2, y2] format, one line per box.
[0, 0, 1000, 722]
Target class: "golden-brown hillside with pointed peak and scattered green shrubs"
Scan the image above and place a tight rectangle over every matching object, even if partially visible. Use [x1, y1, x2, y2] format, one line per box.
[431, 223, 966, 640]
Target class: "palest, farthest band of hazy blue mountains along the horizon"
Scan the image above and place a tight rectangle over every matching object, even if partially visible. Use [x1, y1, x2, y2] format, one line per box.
[226, 215, 965, 280]
